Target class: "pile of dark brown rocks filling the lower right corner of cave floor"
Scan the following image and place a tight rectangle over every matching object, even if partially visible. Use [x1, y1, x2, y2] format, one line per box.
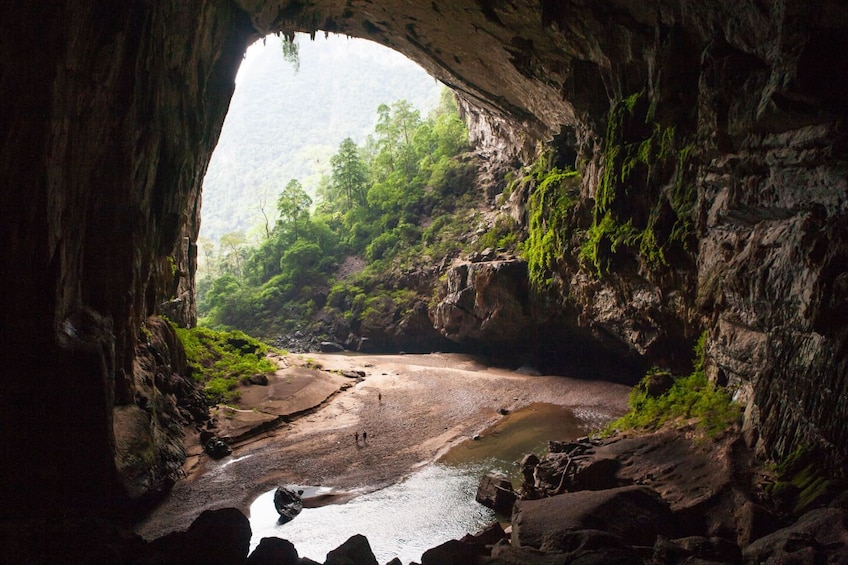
[470, 432, 848, 564]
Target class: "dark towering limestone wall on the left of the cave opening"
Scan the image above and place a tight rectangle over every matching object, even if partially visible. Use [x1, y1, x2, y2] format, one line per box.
[0, 0, 254, 514]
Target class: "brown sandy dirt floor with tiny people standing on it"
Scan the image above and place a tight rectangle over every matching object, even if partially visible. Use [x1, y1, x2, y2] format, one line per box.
[137, 353, 629, 539]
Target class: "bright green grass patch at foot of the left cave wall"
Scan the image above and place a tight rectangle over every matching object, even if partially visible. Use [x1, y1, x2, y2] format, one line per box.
[174, 326, 277, 406]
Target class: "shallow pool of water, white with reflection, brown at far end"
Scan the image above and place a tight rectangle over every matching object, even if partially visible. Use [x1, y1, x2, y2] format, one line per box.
[250, 398, 585, 563]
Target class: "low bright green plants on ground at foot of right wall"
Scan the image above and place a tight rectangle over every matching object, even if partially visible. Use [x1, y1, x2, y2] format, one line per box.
[605, 334, 741, 437]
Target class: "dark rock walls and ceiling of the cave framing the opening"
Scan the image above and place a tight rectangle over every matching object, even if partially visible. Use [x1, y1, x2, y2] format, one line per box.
[0, 0, 848, 556]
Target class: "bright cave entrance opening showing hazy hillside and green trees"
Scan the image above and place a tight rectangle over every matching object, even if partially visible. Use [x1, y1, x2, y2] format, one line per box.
[197, 34, 468, 349]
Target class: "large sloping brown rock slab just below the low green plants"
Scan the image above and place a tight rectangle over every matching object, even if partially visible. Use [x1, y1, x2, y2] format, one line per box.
[523, 431, 760, 545]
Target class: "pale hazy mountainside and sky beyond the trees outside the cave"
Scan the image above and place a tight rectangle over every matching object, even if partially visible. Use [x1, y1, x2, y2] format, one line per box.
[201, 35, 442, 242]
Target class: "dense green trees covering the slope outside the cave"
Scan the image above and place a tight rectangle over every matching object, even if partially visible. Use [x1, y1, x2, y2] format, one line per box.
[198, 89, 474, 337]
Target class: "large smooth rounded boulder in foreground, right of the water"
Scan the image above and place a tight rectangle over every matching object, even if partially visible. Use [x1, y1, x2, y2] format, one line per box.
[512, 486, 674, 551]
